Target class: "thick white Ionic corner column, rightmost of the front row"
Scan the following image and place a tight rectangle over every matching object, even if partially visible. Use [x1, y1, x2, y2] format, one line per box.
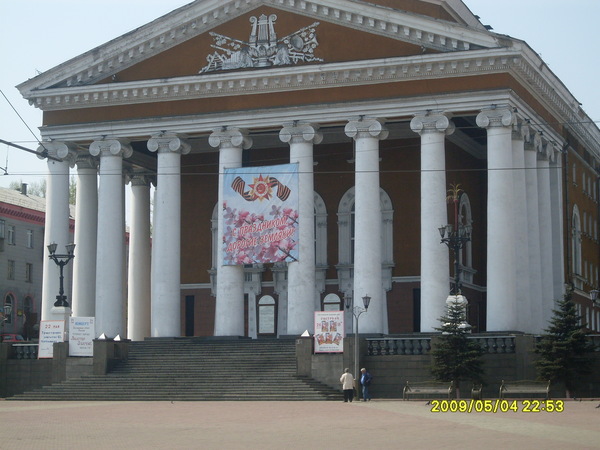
[477, 106, 517, 331]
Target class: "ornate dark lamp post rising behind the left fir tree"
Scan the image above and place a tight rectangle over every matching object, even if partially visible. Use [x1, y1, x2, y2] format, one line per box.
[439, 184, 471, 327]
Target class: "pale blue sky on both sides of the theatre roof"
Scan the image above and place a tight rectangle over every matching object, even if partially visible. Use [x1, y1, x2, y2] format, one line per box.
[0, 0, 600, 187]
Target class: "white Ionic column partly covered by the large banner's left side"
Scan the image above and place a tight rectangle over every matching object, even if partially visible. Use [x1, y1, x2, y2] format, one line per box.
[208, 127, 252, 336]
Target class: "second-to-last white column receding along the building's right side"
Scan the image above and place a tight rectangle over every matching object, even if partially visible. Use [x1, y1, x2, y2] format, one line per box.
[536, 135, 558, 327]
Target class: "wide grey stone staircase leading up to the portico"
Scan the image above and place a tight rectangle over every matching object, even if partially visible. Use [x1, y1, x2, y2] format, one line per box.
[7, 338, 341, 401]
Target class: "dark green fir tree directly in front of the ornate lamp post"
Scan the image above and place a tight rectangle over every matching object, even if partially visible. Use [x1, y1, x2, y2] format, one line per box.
[431, 302, 485, 395]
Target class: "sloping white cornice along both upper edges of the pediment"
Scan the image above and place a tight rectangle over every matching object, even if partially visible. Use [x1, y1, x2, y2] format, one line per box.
[18, 0, 499, 98]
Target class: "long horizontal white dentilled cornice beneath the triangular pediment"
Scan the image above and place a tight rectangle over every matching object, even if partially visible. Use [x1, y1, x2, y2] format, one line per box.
[29, 49, 519, 111]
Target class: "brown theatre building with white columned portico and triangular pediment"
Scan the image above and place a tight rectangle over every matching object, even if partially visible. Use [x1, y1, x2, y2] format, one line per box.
[18, 0, 600, 340]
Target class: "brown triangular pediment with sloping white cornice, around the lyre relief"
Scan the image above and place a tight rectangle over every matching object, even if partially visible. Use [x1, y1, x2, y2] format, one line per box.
[19, 0, 498, 98]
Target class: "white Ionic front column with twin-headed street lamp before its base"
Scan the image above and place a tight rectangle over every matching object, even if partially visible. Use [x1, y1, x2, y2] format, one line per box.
[345, 116, 388, 333]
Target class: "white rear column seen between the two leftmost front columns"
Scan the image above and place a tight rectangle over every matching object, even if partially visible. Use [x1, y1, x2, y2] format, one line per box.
[72, 155, 98, 317]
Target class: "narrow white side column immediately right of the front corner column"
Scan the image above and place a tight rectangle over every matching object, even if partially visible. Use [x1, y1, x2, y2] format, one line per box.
[512, 123, 532, 331]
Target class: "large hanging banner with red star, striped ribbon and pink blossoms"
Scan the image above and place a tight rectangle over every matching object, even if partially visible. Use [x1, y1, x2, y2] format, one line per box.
[222, 164, 298, 266]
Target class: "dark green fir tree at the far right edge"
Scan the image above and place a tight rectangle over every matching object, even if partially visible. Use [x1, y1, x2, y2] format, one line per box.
[535, 288, 593, 398]
